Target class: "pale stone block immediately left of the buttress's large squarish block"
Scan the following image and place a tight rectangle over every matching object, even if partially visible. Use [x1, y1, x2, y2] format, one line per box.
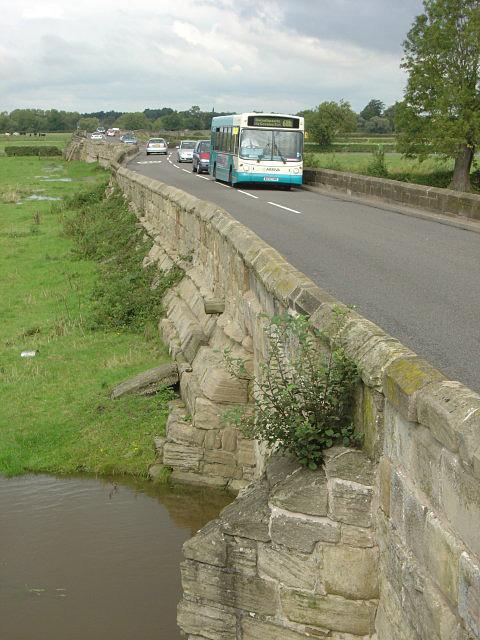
[258, 543, 319, 591]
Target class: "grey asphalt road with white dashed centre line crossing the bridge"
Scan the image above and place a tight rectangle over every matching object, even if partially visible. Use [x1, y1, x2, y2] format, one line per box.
[128, 152, 480, 391]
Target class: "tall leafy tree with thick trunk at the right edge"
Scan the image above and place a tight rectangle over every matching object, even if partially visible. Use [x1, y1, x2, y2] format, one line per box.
[396, 0, 480, 191]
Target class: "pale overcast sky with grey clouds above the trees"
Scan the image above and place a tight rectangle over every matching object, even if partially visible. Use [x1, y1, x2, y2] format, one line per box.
[0, 0, 422, 112]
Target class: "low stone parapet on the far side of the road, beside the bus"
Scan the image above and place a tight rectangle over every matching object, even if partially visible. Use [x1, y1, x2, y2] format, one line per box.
[303, 169, 480, 220]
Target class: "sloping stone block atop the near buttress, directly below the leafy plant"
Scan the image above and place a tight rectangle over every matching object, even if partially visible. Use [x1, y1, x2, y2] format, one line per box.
[270, 469, 328, 516]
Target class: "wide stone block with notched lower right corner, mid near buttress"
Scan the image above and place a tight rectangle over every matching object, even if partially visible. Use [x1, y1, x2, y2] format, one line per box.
[270, 512, 340, 553]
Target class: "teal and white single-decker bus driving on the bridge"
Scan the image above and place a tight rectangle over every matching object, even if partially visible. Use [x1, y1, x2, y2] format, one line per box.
[209, 113, 304, 185]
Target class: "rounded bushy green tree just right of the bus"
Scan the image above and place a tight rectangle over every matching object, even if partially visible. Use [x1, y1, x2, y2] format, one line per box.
[300, 100, 357, 147]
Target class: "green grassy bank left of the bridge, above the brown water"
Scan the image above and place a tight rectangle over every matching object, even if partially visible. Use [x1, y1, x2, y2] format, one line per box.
[0, 157, 176, 476]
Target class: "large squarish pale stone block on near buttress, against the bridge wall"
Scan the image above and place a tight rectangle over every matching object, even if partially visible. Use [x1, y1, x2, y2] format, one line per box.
[321, 545, 379, 600]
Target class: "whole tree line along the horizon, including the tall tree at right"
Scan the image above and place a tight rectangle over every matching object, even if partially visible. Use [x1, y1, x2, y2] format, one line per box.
[0, 0, 480, 191]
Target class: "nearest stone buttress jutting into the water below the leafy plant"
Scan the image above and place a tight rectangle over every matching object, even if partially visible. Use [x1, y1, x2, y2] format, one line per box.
[178, 449, 379, 640]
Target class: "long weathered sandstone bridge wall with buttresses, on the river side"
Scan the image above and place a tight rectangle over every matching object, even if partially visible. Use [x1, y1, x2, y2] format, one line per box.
[64, 141, 480, 640]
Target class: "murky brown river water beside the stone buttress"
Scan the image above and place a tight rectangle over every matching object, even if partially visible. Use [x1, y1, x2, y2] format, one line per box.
[0, 475, 231, 640]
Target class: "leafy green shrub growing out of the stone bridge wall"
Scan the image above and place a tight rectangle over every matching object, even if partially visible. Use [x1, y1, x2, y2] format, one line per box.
[225, 308, 358, 469]
